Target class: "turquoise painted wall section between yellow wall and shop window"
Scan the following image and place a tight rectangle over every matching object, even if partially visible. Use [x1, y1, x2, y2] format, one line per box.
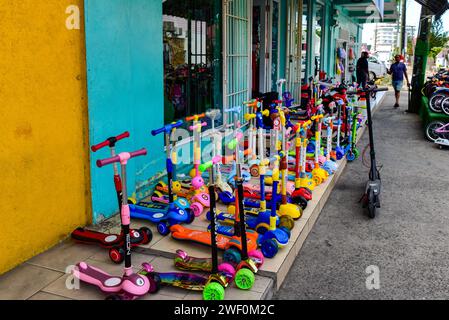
[85, 0, 164, 222]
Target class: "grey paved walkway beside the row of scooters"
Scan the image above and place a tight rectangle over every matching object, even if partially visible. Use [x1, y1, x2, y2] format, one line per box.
[275, 92, 449, 299]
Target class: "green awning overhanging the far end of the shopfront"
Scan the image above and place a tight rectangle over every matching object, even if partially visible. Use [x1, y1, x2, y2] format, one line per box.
[334, 0, 399, 24]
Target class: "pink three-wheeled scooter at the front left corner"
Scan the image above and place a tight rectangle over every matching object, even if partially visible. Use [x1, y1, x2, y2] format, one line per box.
[73, 149, 157, 300]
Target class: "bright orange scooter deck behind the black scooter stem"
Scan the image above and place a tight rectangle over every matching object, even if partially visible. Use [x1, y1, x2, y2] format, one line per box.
[170, 224, 258, 251]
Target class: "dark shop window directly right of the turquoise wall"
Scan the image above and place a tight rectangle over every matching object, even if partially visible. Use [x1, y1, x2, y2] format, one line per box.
[163, 0, 222, 123]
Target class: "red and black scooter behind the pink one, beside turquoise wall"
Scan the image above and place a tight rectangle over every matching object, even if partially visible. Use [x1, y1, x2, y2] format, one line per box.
[71, 132, 153, 263]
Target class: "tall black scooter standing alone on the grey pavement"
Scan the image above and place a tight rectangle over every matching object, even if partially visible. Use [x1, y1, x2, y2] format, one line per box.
[356, 88, 388, 219]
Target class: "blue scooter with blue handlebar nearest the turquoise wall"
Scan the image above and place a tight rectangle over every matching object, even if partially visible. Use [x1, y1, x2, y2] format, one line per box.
[130, 121, 195, 236]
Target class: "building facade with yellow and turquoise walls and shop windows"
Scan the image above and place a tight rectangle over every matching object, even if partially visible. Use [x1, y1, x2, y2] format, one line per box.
[0, 0, 392, 273]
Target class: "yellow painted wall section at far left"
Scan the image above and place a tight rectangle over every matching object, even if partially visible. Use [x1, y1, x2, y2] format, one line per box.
[0, 0, 91, 274]
